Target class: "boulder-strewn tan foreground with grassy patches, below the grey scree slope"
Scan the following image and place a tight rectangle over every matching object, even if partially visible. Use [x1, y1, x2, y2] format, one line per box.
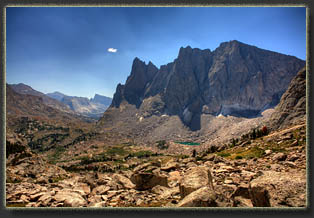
[6, 121, 307, 207]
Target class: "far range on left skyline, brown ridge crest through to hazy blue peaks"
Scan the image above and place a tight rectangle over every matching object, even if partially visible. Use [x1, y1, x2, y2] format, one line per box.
[9, 83, 112, 119]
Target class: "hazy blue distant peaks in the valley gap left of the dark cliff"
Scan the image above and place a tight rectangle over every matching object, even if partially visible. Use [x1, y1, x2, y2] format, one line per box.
[47, 92, 112, 118]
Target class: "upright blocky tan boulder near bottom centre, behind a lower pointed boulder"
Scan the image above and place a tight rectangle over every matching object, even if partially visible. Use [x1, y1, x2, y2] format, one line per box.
[179, 166, 214, 198]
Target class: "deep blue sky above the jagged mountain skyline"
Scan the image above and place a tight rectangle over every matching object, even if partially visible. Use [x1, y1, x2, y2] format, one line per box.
[6, 7, 306, 98]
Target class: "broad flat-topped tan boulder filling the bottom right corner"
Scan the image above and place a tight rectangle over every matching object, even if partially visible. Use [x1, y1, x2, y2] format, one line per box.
[249, 171, 306, 207]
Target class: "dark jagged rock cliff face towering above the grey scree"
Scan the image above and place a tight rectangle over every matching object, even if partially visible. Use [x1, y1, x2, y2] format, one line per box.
[100, 40, 305, 130]
